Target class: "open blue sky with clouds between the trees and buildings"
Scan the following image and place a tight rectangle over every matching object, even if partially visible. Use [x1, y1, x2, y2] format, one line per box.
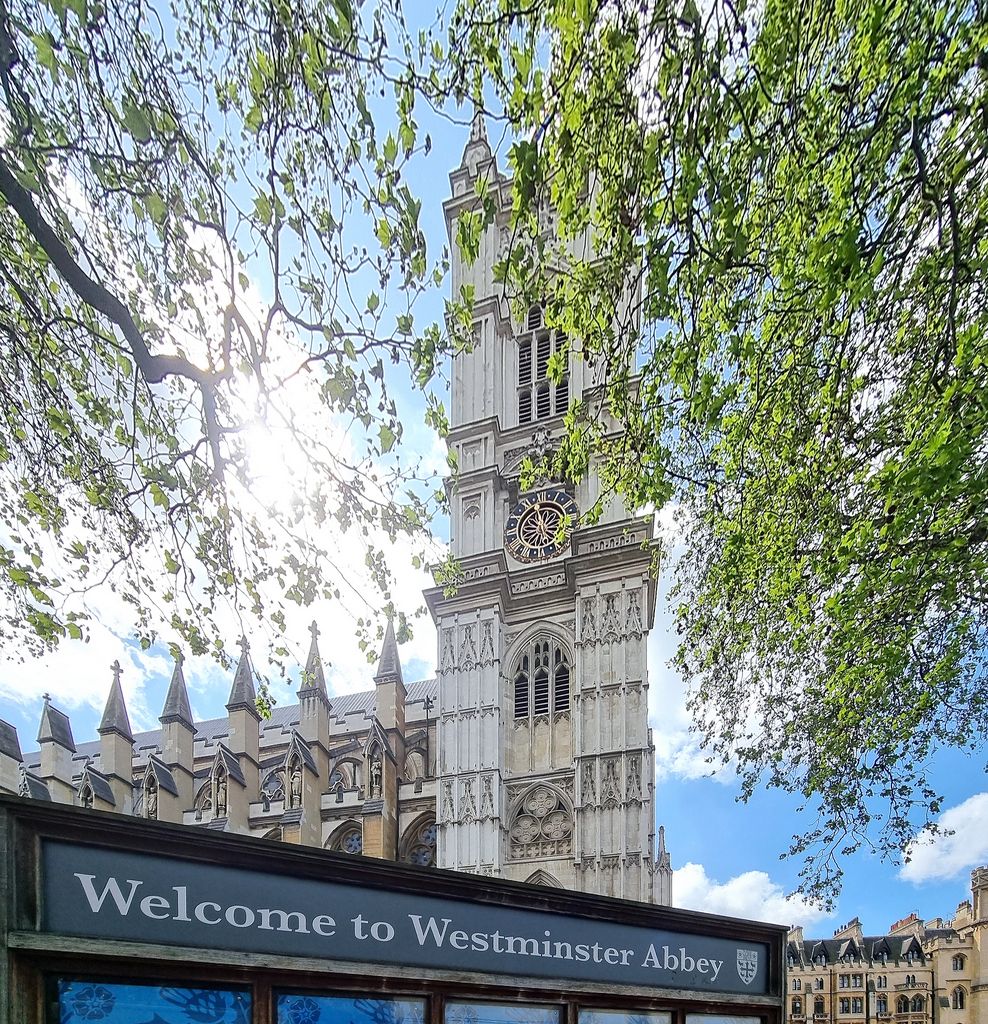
[0, 12, 988, 936]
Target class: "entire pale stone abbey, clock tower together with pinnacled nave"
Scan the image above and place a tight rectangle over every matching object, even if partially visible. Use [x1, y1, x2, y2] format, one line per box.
[0, 119, 672, 904]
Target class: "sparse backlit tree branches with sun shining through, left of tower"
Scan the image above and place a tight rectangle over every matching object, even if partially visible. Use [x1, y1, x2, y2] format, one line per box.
[0, 0, 445, 679]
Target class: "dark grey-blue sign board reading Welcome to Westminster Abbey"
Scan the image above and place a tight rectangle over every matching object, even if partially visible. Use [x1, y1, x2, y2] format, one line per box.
[42, 841, 768, 994]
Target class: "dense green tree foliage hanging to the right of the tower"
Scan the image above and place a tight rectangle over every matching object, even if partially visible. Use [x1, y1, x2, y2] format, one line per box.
[450, 0, 988, 899]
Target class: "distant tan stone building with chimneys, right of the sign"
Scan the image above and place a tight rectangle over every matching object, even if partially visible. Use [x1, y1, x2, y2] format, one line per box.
[786, 867, 988, 1024]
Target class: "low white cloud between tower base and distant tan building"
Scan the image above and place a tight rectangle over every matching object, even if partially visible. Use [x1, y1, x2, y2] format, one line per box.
[673, 863, 832, 926]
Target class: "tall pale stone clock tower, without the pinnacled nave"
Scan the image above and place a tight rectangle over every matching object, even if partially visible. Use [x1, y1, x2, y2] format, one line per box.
[426, 118, 672, 904]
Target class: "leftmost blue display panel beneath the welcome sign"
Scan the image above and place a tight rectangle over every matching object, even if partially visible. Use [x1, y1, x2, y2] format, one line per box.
[56, 978, 251, 1024]
